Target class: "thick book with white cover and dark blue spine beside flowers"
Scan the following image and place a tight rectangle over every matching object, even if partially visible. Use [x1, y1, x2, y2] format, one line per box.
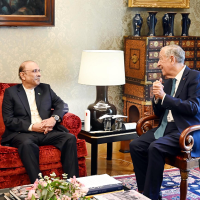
[72, 174, 123, 196]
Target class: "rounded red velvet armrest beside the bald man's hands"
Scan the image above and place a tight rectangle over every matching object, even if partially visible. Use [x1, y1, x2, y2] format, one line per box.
[61, 113, 82, 138]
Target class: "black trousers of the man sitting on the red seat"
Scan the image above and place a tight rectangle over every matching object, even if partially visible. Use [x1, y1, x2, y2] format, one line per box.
[10, 130, 79, 183]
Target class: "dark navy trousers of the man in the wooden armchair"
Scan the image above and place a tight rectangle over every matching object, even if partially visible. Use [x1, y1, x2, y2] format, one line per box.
[130, 122, 180, 200]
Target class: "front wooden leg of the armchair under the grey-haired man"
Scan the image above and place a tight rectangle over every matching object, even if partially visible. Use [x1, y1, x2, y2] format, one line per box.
[180, 170, 190, 200]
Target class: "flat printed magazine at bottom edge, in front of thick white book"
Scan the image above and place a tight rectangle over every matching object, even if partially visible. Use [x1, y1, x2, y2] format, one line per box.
[93, 190, 150, 200]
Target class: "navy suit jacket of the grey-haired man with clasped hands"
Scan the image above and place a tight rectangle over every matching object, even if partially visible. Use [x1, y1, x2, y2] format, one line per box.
[153, 66, 200, 157]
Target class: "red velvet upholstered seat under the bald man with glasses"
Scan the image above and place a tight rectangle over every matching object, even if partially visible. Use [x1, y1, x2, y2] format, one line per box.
[0, 83, 87, 189]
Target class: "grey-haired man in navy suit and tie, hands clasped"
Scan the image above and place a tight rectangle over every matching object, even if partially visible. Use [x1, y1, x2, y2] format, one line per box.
[130, 45, 200, 200]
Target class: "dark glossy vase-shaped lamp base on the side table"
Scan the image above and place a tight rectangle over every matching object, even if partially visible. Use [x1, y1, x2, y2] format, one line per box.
[88, 86, 117, 131]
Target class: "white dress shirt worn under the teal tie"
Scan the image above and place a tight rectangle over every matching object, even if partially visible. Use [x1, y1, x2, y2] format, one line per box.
[154, 65, 186, 122]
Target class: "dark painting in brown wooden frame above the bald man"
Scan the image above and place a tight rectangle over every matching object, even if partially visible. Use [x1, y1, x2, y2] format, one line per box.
[0, 0, 55, 26]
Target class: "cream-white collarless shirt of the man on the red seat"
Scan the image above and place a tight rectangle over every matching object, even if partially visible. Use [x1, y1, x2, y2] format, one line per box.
[22, 85, 42, 131]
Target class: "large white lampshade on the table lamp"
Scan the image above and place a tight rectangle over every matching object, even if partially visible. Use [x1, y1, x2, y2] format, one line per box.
[78, 50, 125, 86]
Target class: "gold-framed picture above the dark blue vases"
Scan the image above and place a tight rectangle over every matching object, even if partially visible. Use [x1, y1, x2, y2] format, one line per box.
[128, 0, 190, 8]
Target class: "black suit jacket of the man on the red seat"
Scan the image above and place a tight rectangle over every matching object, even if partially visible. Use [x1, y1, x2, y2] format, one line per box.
[1, 83, 68, 143]
